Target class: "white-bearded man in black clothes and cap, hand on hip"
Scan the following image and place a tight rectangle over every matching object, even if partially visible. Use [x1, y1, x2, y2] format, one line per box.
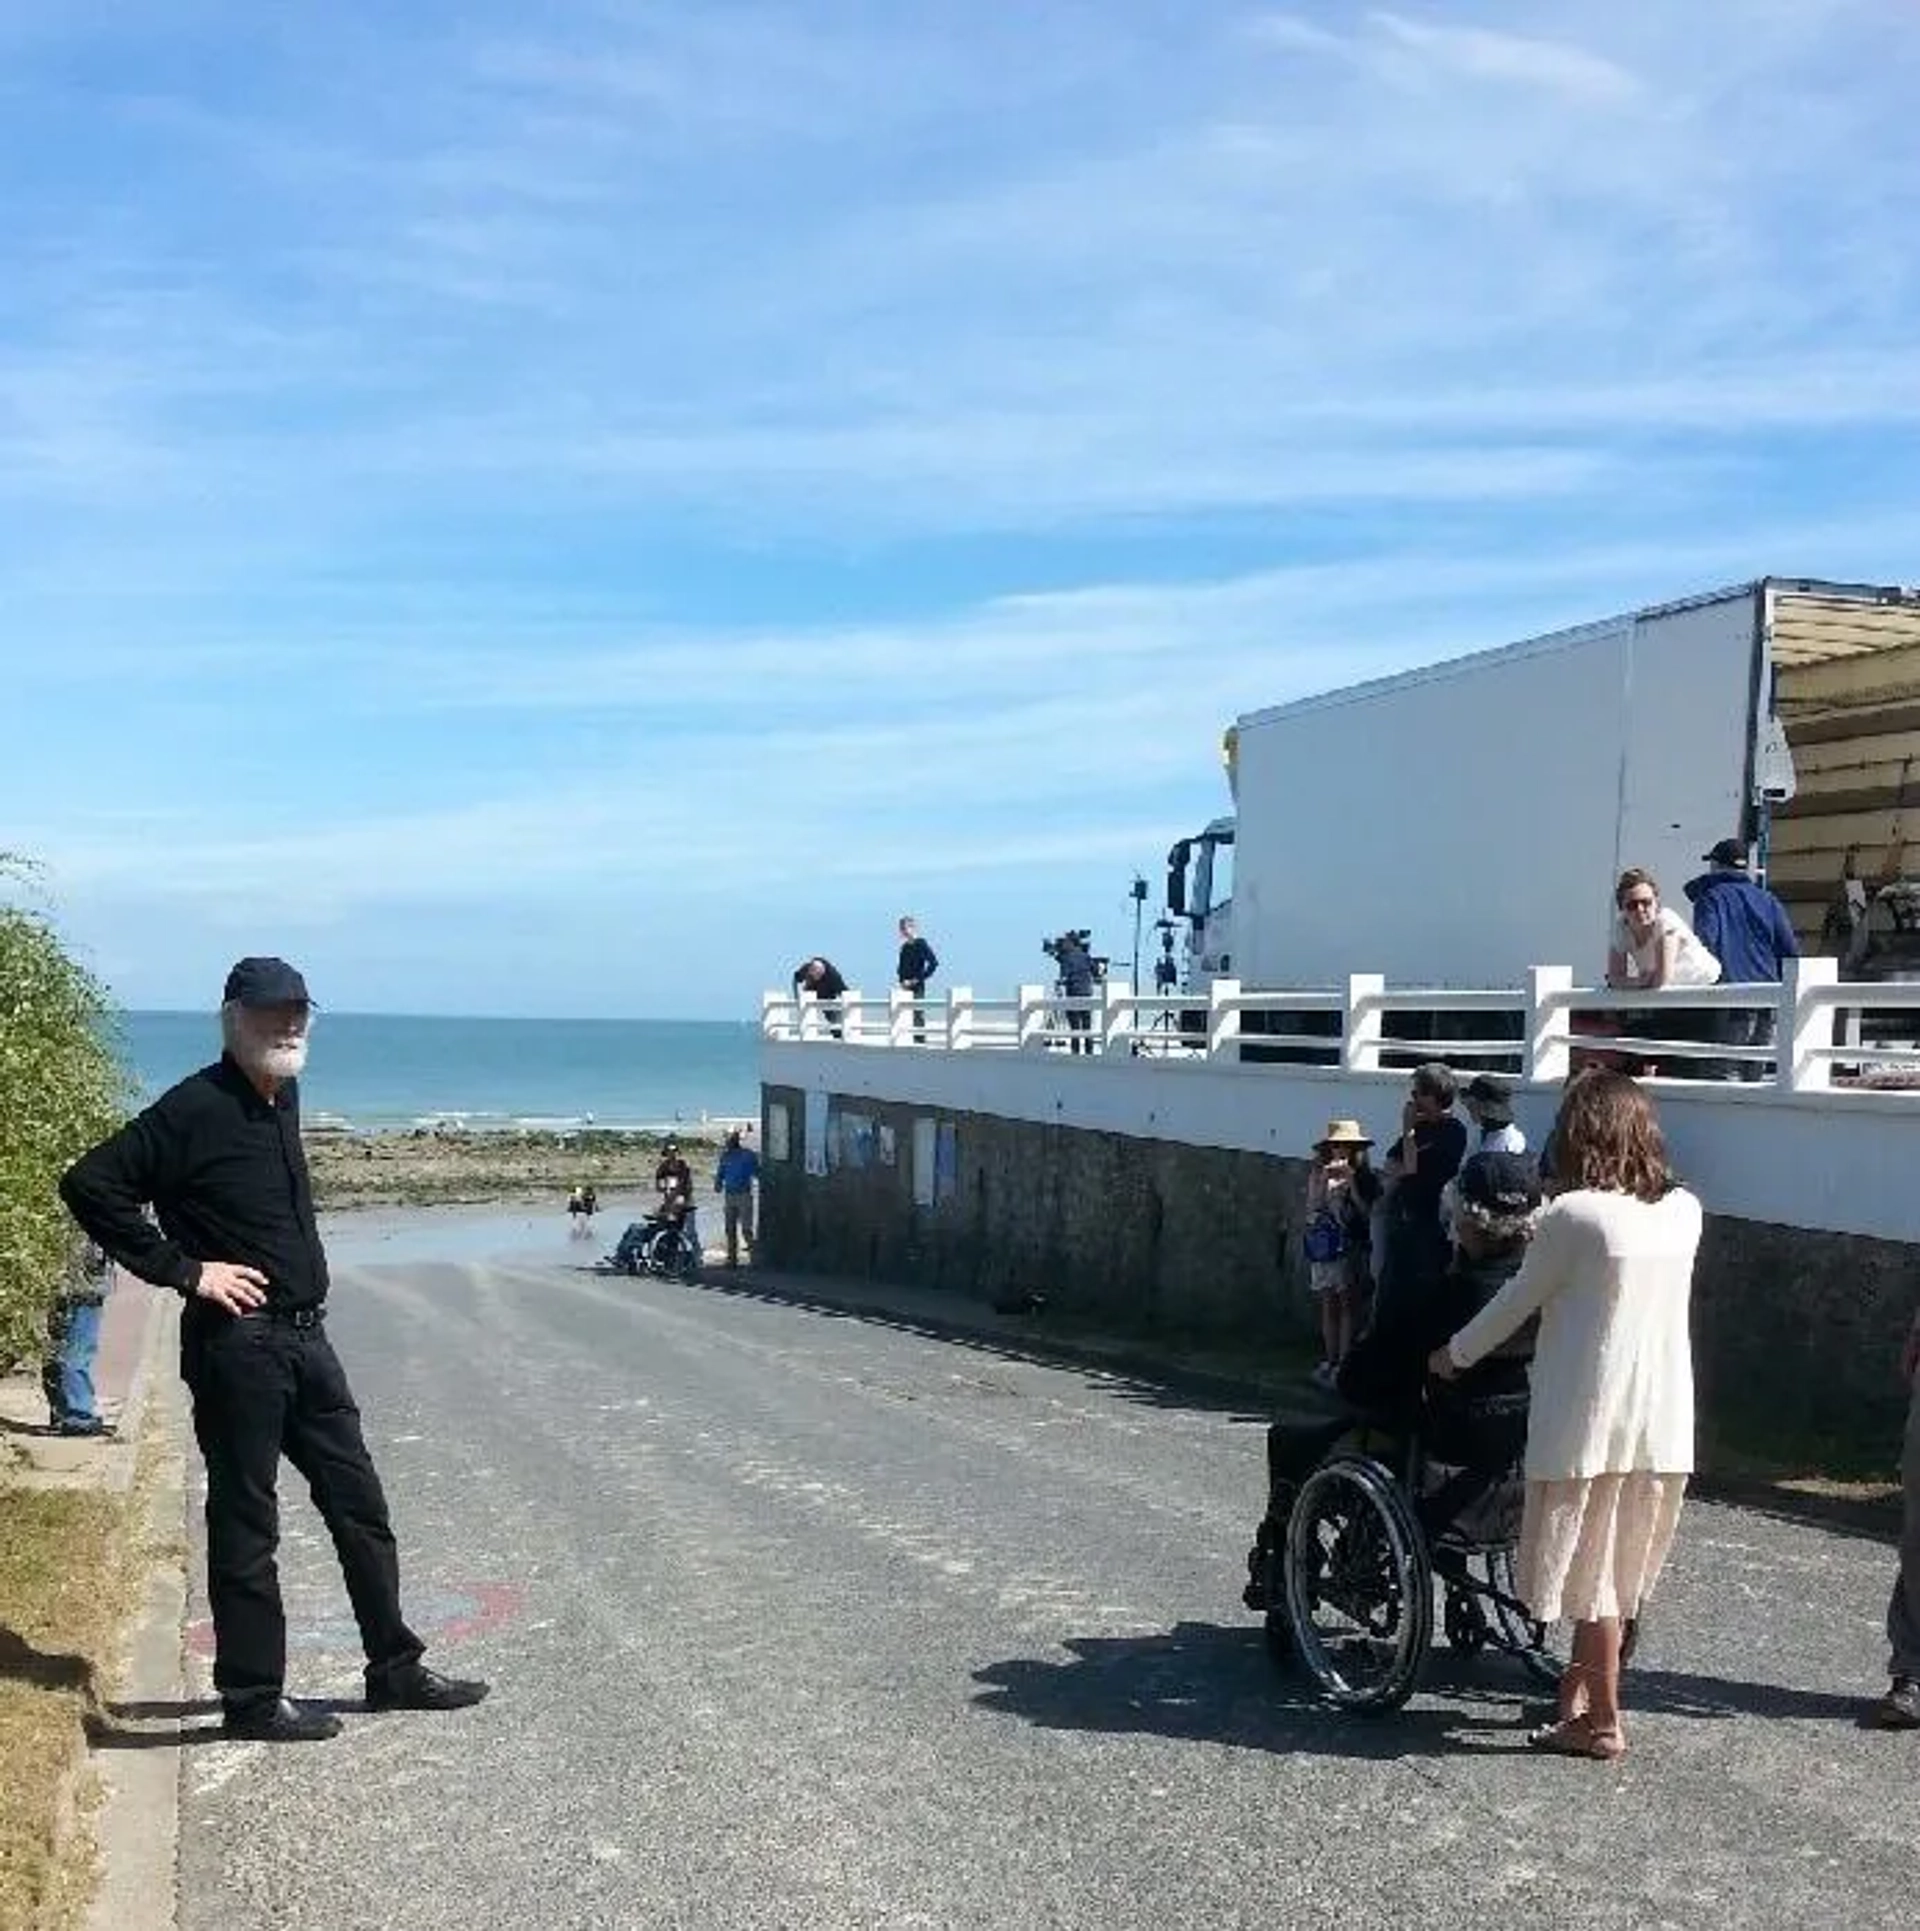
[60, 958, 487, 1744]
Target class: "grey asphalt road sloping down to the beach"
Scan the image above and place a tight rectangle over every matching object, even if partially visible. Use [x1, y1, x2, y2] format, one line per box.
[180, 1222, 1920, 1931]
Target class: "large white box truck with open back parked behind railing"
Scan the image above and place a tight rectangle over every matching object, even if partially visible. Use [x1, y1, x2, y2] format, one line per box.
[1167, 577, 1920, 993]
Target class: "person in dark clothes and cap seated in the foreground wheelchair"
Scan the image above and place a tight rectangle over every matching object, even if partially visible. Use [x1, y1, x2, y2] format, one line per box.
[1244, 1153, 1541, 1609]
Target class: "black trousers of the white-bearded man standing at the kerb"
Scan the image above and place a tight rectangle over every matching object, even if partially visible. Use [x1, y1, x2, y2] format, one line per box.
[180, 1305, 425, 1707]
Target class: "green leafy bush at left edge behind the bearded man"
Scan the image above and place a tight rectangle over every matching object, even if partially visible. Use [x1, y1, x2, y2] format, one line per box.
[0, 854, 131, 1367]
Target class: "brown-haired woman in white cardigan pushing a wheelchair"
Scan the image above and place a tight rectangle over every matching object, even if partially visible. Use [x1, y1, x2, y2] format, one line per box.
[1429, 1072, 1702, 1761]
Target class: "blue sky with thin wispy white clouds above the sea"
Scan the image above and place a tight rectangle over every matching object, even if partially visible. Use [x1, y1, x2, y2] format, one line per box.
[0, 0, 1920, 1016]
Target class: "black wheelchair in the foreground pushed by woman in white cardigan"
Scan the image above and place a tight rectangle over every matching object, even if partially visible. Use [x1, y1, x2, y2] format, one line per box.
[1246, 1400, 1572, 1717]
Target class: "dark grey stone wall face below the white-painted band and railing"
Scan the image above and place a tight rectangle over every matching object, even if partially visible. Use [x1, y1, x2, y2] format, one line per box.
[759, 1085, 1920, 1462]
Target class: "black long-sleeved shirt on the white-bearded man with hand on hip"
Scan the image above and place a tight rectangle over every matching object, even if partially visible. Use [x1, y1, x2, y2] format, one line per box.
[60, 1058, 326, 1307]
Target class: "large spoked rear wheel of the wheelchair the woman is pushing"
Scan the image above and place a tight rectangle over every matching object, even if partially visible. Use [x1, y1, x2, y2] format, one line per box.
[1286, 1454, 1433, 1715]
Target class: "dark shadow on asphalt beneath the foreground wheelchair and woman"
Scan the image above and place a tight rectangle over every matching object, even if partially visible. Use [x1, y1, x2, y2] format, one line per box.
[974, 1622, 1864, 1761]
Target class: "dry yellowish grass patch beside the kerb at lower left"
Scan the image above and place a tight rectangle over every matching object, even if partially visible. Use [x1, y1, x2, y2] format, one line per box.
[0, 1485, 129, 1931]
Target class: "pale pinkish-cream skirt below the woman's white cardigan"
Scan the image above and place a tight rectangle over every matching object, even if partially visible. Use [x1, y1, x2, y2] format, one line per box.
[1514, 1471, 1686, 1622]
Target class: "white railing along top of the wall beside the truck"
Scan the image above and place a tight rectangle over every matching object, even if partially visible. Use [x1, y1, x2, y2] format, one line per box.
[761, 958, 1920, 1093]
